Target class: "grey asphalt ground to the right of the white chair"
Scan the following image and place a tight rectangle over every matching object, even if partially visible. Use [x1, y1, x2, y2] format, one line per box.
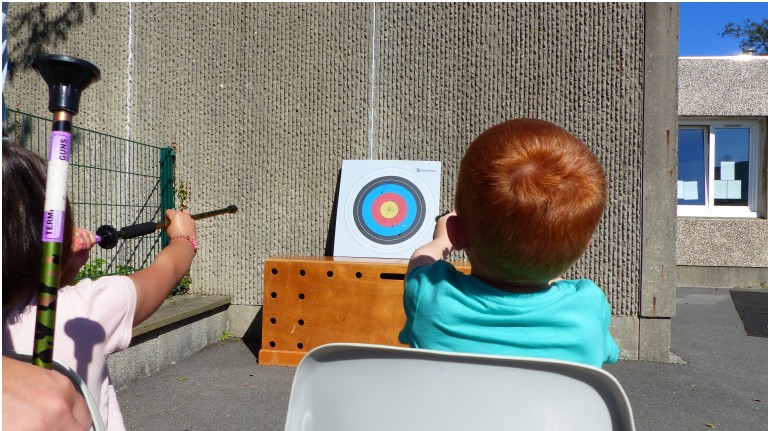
[605, 289, 768, 431]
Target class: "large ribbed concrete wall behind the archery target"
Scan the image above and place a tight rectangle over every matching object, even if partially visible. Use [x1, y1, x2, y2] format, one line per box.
[6, 3, 677, 360]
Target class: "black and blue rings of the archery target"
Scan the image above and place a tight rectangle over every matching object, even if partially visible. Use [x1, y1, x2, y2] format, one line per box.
[353, 176, 426, 245]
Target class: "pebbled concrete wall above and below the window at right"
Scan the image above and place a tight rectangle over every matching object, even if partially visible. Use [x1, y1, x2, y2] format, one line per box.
[677, 57, 768, 276]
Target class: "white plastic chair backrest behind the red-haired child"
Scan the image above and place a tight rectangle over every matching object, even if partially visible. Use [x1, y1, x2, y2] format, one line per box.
[285, 344, 635, 431]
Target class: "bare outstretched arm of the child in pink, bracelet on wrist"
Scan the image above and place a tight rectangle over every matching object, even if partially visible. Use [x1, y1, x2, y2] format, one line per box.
[128, 210, 197, 326]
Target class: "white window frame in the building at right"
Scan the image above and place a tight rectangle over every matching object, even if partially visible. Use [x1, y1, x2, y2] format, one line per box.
[676, 117, 763, 218]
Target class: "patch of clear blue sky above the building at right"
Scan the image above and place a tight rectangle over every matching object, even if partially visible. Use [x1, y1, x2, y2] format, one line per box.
[679, 2, 768, 57]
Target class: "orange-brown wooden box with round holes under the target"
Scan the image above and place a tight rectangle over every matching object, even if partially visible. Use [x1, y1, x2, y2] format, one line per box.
[259, 256, 469, 366]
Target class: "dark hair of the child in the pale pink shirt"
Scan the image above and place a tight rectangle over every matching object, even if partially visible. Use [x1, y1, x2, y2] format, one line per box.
[3, 141, 73, 309]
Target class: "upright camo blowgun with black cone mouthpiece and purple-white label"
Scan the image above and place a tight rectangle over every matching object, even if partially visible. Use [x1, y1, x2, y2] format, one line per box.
[32, 54, 101, 369]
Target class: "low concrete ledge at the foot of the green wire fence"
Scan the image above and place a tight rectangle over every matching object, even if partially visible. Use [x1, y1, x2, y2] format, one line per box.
[107, 295, 231, 388]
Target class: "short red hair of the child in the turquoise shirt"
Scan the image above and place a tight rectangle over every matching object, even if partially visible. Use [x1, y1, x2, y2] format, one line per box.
[456, 119, 606, 282]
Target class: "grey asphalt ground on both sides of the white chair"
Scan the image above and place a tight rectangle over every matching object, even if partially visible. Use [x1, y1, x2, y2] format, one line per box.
[117, 288, 768, 431]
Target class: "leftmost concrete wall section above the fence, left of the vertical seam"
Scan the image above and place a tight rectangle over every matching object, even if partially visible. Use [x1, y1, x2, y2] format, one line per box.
[5, 3, 131, 138]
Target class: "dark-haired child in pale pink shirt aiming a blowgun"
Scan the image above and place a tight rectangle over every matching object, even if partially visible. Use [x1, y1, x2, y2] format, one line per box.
[3, 142, 197, 430]
